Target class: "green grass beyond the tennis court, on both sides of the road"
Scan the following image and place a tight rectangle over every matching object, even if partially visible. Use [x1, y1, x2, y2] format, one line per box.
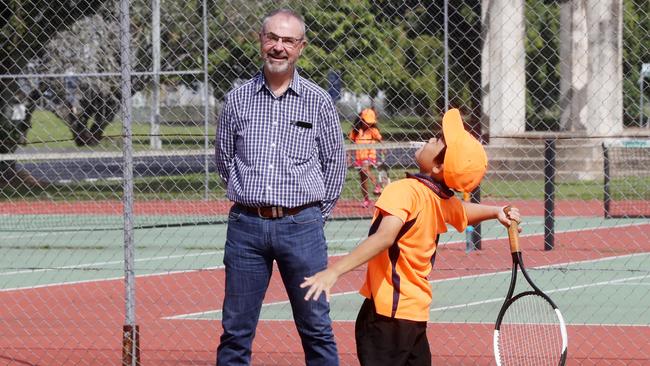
[8, 111, 650, 201]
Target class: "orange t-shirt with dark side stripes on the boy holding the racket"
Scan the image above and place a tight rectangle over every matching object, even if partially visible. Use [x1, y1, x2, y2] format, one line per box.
[360, 178, 467, 321]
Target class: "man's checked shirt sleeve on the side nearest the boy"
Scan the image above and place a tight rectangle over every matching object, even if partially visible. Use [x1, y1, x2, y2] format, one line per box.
[319, 99, 346, 218]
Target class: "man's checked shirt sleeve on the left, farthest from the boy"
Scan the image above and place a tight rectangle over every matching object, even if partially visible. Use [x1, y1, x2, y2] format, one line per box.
[214, 97, 235, 184]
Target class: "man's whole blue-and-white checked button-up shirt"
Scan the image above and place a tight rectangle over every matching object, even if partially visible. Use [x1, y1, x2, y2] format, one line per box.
[215, 71, 346, 217]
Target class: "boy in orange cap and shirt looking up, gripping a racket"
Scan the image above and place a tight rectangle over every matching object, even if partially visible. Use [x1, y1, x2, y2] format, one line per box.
[301, 109, 519, 366]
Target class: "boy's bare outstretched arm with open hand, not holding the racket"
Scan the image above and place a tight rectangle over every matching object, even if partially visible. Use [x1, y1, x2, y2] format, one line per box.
[300, 213, 404, 302]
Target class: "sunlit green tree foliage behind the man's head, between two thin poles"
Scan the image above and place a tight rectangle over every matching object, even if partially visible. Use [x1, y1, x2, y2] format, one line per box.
[202, 0, 442, 115]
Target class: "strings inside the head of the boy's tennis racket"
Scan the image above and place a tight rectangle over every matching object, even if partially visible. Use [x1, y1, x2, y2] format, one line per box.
[499, 294, 563, 366]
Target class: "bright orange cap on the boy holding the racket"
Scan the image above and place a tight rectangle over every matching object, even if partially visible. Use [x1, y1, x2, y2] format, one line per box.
[442, 109, 487, 192]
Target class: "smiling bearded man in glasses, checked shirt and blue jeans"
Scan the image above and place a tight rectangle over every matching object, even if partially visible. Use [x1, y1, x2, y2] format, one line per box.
[216, 9, 346, 366]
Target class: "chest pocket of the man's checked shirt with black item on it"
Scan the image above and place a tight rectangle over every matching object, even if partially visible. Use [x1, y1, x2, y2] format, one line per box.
[280, 120, 316, 161]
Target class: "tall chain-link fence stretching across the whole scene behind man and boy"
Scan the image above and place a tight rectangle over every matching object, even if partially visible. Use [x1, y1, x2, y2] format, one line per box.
[0, 0, 650, 365]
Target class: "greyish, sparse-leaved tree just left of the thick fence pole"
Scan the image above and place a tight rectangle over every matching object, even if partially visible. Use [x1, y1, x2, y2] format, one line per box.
[28, 9, 120, 146]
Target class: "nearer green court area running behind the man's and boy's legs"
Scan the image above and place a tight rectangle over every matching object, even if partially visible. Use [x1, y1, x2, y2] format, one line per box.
[173, 253, 650, 326]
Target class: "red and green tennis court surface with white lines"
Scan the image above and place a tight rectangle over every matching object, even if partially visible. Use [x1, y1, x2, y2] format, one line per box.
[0, 202, 650, 365]
